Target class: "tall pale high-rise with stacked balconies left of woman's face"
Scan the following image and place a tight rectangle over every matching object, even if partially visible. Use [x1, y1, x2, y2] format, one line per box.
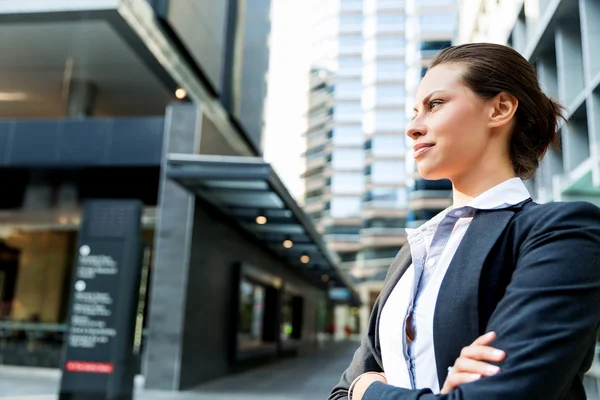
[304, 0, 456, 327]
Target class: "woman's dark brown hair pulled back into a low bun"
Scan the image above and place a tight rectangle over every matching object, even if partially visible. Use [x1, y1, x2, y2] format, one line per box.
[429, 43, 564, 179]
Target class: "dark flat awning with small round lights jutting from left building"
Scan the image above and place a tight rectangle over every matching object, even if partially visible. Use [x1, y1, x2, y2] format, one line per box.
[166, 154, 360, 305]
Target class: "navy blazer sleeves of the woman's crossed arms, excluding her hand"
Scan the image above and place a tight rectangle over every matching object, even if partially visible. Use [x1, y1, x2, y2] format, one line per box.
[330, 203, 600, 400]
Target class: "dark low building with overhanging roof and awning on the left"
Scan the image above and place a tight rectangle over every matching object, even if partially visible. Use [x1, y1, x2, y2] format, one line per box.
[0, 0, 358, 391]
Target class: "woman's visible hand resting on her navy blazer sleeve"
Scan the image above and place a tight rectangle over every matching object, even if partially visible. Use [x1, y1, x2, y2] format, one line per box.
[440, 332, 506, 394]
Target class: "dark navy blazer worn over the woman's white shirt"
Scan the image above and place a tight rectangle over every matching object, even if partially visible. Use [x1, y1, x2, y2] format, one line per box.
[329, 200, 600, 400]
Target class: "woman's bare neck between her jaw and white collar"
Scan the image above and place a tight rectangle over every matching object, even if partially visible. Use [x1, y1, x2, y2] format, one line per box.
[452, 164, 515, 207]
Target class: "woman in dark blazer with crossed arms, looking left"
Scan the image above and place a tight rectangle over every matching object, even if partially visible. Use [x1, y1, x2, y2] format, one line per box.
[330, 43, 600, 400]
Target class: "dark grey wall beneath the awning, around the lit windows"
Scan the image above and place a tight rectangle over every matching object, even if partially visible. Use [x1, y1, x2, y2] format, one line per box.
[181, 202, 325, 388]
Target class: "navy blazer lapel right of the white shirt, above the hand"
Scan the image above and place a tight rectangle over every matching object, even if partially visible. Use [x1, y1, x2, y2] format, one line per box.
[433, 208, 515, 388]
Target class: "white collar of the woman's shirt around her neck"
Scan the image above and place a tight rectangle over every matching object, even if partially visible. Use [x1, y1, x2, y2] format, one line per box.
[406, 178, 531, 238]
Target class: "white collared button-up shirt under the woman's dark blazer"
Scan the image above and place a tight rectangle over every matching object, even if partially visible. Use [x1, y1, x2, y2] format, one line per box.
[379, 178, 530, 394]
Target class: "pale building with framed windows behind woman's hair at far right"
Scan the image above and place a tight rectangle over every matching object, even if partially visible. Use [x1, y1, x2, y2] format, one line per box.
[461, 0, 600, 398]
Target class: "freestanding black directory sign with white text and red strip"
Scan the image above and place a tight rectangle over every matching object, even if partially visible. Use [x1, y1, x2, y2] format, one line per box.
[60, 200, 142, 400]
